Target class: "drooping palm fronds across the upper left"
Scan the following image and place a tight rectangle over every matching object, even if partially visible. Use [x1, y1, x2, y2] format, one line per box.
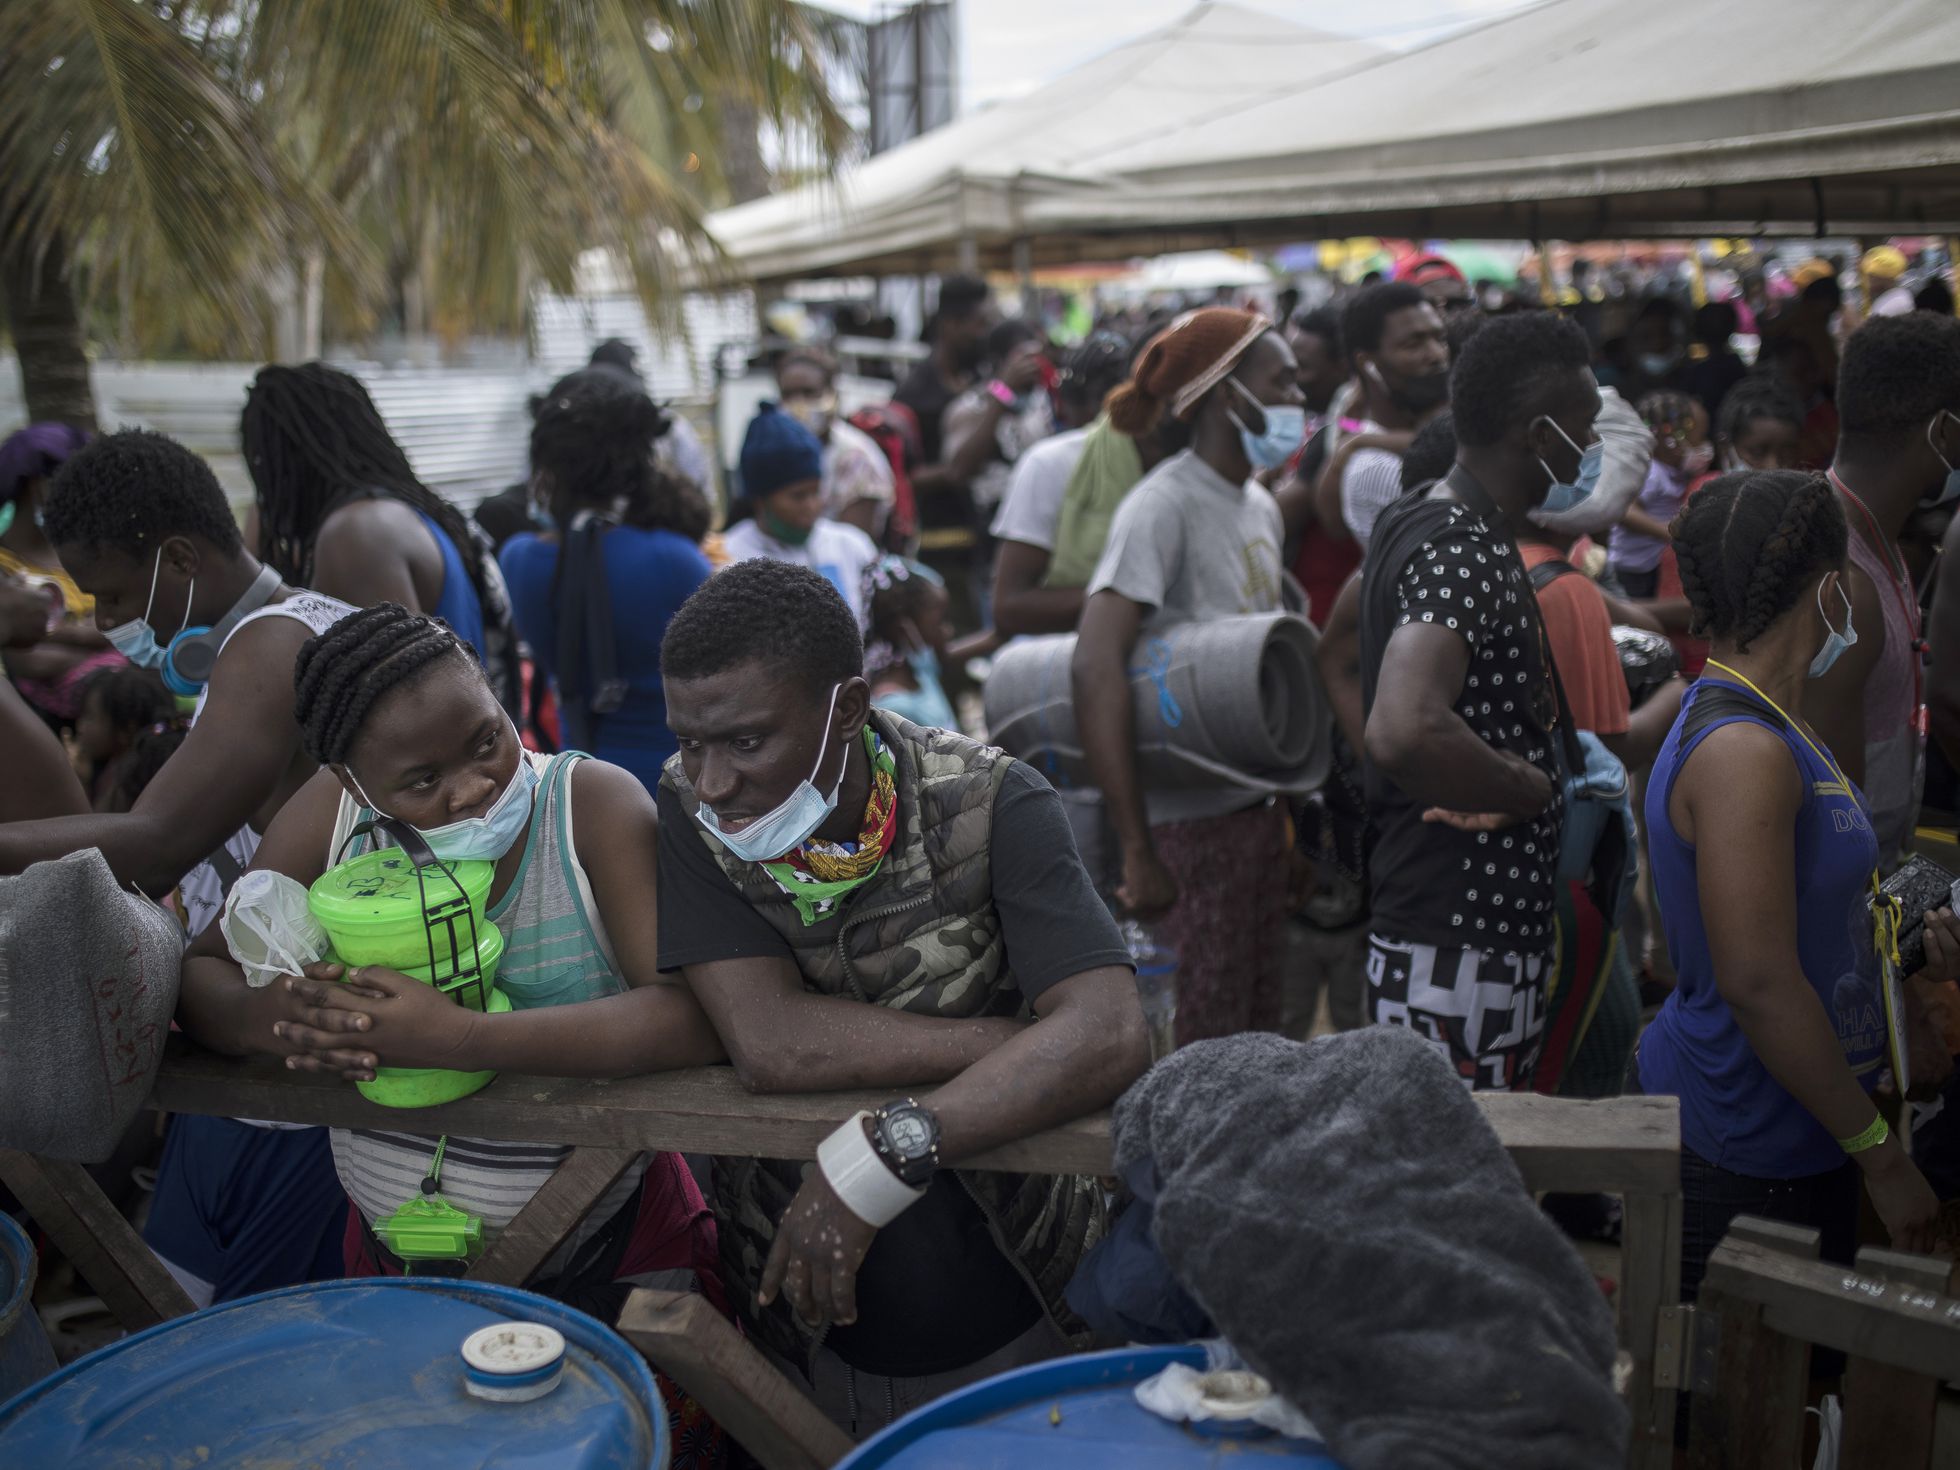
[0, 0, 845, 355]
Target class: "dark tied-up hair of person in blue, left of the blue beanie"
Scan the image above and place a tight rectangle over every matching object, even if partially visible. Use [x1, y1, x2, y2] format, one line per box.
[531, 368, 713, 543]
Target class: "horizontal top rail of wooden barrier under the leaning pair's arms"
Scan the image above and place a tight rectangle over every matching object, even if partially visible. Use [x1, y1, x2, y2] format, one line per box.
[151, 1037, 1680, 1194]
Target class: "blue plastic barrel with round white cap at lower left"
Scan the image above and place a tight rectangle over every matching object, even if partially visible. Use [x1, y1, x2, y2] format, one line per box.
[0, 1278, 666, 1470]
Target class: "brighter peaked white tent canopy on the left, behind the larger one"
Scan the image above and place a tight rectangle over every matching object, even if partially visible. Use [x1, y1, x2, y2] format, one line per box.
[708, 4, 1382, 280]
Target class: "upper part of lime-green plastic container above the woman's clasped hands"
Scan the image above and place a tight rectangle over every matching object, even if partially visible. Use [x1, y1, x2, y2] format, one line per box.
[306, 847, 496, 976]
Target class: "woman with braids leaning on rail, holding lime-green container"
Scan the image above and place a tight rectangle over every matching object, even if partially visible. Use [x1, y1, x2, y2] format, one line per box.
[178, 602, 723, 1411]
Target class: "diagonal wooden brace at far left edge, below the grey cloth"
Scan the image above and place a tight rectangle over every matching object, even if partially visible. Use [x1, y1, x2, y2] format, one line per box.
[0, 1149, 196, 1333]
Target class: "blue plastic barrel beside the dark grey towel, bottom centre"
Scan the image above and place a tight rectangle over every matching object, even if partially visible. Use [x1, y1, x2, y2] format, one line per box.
[842, 1347, 1341, 1470]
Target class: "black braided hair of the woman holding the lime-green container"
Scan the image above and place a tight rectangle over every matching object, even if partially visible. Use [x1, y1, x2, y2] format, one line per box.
[292, 602, 476, 766]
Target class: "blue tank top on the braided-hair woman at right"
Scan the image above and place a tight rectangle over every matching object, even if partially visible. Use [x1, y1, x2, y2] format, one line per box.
[1639, 674, 1886, 1180]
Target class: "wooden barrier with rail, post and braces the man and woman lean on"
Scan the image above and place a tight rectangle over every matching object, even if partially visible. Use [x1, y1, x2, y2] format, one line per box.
[0, 1037, 1682, 1470]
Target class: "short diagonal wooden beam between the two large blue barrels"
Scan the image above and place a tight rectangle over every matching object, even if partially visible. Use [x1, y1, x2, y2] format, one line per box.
[619, 1288, 853, 1470]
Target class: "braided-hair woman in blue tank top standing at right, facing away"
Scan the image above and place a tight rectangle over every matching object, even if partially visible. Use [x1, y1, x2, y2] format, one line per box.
[1635, 470, 1960, 1299]
